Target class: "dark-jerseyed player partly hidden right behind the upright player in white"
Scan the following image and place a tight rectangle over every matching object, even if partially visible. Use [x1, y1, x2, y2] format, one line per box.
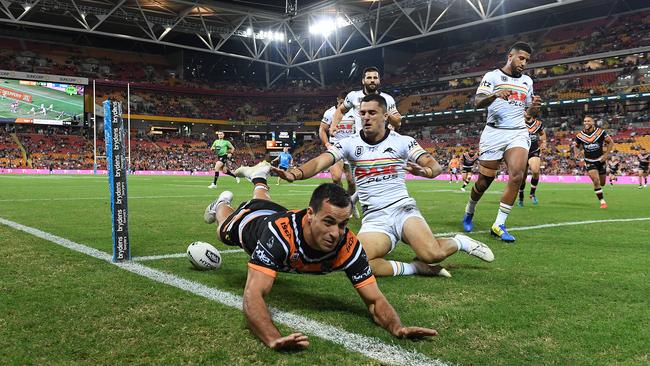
[517, 113, 546, 207]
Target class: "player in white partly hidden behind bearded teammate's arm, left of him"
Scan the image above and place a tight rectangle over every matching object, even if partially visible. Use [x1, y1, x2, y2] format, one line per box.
[318, 92, 360, 218]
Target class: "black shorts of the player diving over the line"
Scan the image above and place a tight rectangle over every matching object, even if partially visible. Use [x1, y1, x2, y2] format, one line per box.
[217, 199, 287, 254]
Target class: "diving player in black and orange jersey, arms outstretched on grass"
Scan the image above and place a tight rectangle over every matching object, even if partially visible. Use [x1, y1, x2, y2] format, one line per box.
[204, 162, 437, 349]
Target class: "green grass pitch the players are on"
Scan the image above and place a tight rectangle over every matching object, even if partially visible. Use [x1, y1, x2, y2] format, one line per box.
[0, 175, 650, 365]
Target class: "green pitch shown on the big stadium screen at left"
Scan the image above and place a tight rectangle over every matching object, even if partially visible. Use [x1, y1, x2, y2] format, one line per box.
[0, 79, 84, 120]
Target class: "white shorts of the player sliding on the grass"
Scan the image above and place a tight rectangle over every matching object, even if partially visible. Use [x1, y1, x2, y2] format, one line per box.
[359, 198, 424, 253]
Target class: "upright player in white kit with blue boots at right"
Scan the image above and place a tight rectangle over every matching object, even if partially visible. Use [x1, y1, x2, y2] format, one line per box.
[462, 42, 541, 243]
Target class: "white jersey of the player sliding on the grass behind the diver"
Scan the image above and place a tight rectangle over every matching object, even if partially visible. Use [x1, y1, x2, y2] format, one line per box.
[327, 131, 427, 212]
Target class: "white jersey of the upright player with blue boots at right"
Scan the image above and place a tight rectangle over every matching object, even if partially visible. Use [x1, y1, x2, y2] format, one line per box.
[476, 69, 533, 130]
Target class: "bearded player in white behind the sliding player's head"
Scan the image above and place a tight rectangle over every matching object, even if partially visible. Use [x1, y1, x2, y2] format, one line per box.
[330, 66, 402, 136]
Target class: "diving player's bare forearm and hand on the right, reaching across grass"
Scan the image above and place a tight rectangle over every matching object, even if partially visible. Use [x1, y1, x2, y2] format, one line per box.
[357, 282, 438, 339]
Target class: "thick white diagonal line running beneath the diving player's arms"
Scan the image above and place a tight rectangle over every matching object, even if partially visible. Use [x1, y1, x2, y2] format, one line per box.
[0, 217, 448, 366]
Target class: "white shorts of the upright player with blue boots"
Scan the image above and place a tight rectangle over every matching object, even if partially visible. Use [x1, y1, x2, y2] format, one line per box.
[479, 126, 530, 160]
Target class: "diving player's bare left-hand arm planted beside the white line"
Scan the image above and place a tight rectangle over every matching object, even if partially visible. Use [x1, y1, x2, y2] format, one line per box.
[243, 268, 309, 350]
